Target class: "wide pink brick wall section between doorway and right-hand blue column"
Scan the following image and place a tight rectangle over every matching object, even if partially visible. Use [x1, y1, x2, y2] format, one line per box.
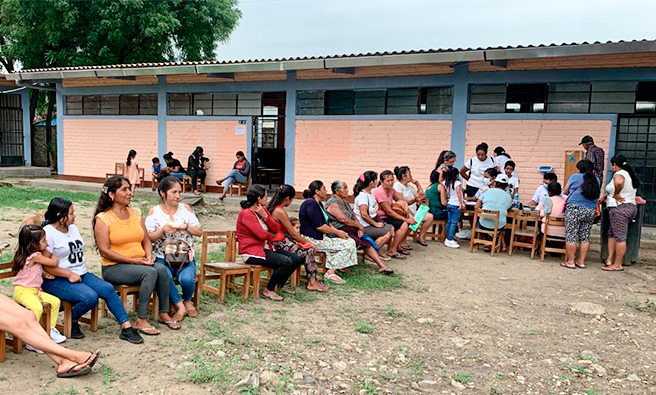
[294, 120, 451, 191]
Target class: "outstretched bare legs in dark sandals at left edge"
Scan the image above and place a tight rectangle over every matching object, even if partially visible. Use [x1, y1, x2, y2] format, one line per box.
[0, 294, 100, 378]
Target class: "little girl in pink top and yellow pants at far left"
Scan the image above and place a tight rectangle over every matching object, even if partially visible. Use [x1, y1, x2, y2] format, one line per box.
[12, 225, 66, 354]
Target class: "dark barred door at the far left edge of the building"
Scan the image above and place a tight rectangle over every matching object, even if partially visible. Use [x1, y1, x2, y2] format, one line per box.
[0, 94, 24, 166]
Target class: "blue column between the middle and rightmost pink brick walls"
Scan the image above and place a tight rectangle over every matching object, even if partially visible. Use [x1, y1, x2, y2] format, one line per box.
[448, 63, 469, 167]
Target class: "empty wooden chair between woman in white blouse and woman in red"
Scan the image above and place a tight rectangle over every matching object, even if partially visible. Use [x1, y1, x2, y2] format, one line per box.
[200, 230, 254, 303]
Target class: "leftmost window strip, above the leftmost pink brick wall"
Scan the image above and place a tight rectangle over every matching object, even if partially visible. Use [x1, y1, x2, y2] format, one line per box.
[66, 94, 157, 115]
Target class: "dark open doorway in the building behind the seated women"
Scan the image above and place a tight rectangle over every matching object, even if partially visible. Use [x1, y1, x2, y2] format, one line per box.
[251, 92, 286, 189]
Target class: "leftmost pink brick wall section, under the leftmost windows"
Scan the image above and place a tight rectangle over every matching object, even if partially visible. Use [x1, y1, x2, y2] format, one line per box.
[63, 118, 157, 179]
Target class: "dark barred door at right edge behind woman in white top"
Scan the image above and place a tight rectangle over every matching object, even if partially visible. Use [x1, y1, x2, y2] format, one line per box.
[615, 115, 656, 226]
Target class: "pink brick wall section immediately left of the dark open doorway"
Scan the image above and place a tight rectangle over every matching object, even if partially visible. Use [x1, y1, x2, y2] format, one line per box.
[166, 121, 247, 185]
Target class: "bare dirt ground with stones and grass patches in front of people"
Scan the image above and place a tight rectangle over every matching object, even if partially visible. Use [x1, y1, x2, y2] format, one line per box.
[0, 189, 656, 395]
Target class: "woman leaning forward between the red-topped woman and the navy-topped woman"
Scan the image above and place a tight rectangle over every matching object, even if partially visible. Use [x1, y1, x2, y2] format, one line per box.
[267, 184, 328, 292]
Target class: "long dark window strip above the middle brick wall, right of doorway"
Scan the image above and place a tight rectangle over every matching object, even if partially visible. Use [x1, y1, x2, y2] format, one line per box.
[296, 87, 453, 115]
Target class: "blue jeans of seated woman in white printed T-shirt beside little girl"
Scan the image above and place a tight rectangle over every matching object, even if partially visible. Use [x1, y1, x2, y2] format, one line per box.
[42, 273, 128, 325]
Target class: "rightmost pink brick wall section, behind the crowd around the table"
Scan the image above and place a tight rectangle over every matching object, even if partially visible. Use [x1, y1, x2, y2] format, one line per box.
[464, 120, 612, 202]
